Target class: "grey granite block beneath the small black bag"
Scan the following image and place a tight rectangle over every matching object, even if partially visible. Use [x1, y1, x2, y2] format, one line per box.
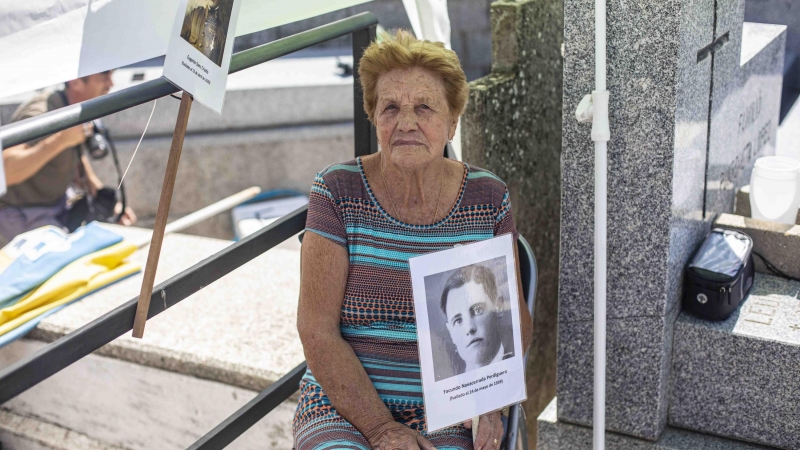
[669, 273, 800, 449]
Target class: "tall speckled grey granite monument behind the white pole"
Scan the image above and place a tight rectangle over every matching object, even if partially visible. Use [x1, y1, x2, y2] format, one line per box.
[539, 0, 788, 449]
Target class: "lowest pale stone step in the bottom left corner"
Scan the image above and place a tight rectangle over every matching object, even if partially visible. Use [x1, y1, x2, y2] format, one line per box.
[0, 410, 129, 450]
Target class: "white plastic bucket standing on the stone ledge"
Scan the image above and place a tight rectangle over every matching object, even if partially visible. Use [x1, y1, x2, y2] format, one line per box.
[750, 156, 800, 224]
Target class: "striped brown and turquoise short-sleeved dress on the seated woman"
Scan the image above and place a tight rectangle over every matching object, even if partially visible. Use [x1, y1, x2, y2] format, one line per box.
[293, 158, 517, 450]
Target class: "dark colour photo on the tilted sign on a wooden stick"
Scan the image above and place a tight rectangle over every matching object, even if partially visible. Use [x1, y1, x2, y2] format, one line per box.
[180, 0, 233, 67]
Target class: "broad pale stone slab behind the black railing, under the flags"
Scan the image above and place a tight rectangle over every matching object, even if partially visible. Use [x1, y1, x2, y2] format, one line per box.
[0, 226, 304, 450]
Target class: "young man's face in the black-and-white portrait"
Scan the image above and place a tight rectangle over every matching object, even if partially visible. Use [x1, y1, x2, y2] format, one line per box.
[446, 281, 500, 370]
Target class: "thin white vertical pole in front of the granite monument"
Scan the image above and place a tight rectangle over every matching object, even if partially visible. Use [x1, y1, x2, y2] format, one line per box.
[592, 0, 611, 450]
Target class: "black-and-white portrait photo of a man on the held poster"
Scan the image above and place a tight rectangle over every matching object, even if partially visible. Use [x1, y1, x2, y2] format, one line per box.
[425, 256, 515, 381]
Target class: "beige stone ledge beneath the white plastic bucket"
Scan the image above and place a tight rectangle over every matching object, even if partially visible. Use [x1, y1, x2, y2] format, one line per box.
[714, 214, 800, 278]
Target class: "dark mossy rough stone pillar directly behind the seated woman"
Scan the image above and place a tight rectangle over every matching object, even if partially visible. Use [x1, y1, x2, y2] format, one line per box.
[462, 0, 563, 445]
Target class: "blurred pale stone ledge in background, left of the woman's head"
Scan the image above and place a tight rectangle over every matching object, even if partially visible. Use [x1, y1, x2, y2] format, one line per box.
[0, 56, 353, 140]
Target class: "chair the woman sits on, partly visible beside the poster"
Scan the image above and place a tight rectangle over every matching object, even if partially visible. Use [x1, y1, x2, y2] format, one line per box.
[500, 235, 538, 450]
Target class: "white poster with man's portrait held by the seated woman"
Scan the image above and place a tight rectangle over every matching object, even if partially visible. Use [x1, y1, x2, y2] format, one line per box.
[409, 234, 527, 432]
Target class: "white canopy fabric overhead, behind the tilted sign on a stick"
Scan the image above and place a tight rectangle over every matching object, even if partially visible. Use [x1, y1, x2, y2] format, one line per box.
[0, 0, 369, 98]
